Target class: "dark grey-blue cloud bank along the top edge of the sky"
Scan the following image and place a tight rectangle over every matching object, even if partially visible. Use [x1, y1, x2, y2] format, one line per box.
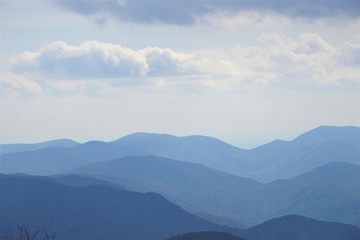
[54, 0, 360, 25]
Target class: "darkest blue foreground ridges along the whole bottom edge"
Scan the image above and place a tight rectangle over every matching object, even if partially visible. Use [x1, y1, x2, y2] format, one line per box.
[0, 175, 360, 240]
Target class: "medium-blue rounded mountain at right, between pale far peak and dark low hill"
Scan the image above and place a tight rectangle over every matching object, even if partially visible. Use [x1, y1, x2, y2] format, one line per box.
[262, 162, 360, 226]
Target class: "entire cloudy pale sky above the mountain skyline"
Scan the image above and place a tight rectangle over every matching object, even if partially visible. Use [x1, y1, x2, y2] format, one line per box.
[0, 0, 360, 148]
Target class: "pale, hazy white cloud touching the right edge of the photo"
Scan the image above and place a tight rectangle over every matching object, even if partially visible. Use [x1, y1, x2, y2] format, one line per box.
[255, 34, 360, 86]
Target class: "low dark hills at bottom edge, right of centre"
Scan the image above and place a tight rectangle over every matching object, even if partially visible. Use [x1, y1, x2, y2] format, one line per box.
[167, 215, 360, 240]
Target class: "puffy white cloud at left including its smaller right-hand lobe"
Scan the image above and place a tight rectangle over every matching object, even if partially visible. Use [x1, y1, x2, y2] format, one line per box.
[13, 41, 191, 79]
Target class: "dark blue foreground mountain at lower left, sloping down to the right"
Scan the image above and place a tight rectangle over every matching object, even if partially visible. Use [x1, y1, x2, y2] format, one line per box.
[0, 174, 230, 240]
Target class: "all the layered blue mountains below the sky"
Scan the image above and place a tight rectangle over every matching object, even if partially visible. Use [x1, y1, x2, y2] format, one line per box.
[0, 126, 360, 240]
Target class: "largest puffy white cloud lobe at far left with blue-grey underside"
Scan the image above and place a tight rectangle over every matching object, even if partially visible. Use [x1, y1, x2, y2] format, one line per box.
[14, 41, 148, 78]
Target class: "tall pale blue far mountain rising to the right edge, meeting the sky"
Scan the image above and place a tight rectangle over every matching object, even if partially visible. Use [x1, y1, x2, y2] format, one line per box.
[253, 126, 360, 182]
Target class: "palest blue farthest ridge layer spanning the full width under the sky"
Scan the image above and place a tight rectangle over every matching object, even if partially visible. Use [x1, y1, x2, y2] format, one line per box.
[0, 127, 360, 182]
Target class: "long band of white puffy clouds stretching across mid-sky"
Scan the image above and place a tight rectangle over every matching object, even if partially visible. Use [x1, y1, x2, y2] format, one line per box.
[12, 34, 360, 93]
